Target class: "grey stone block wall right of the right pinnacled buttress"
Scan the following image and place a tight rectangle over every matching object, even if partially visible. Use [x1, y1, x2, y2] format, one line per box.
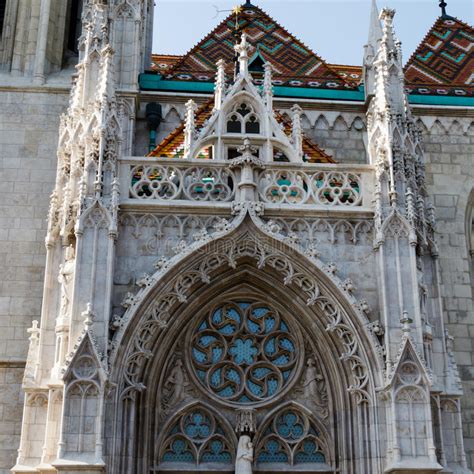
[418, 111, 474, 467]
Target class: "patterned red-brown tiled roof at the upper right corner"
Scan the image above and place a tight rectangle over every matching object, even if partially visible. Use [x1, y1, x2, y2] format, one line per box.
[405, 16, 474, 96]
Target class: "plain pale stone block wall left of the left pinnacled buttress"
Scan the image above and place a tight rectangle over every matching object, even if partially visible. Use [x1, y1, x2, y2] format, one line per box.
[0, 88, 69, 472]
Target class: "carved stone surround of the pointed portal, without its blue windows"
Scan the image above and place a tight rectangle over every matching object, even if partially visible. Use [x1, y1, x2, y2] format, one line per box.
[106, 219, 381, 473]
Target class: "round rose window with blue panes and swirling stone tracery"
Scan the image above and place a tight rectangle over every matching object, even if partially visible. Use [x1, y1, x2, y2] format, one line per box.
[187, 301, 302, 405]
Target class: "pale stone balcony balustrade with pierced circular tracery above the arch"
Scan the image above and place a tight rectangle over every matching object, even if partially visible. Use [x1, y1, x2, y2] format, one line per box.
[120, 157, 374, 216]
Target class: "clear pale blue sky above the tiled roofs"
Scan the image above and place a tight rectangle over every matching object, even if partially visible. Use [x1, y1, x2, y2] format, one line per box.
[153, 0, 474, 65]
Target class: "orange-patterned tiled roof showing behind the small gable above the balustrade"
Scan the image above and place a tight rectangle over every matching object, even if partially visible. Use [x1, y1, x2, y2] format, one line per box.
[148, 98, 335, 163]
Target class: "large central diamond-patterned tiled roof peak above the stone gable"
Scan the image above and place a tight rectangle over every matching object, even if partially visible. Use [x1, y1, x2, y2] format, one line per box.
[157, 2, 355, 89]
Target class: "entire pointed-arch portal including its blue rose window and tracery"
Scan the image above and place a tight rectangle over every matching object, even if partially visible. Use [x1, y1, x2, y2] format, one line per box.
[106, 219, 381, 473]
